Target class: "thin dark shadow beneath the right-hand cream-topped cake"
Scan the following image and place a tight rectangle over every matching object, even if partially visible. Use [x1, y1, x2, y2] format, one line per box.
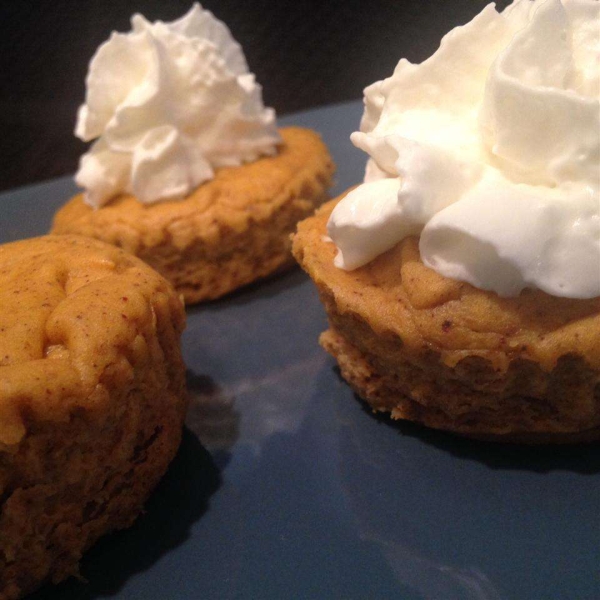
[333, 366, 600, 474]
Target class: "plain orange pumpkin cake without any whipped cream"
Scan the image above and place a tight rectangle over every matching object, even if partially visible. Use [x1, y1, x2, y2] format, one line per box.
[0, 236, 186, 600]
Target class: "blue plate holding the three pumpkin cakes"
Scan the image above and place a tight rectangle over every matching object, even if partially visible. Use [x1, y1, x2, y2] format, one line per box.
[0, 102, 600, 600]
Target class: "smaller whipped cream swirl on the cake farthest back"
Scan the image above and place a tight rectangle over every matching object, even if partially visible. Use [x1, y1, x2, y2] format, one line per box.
[75, 4, 281, 207]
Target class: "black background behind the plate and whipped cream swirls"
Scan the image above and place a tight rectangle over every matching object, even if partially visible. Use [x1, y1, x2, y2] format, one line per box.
[0, 0, 507, 189]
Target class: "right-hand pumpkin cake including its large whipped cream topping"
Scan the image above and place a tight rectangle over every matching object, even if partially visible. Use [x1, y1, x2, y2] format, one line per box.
[293, 0, 600, 443]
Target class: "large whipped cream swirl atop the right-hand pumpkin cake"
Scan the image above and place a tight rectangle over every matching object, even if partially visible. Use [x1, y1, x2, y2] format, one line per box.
[328, 0, 600, 298]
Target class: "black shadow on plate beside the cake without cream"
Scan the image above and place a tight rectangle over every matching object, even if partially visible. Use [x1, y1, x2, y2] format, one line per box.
[28, 428, 221, 600]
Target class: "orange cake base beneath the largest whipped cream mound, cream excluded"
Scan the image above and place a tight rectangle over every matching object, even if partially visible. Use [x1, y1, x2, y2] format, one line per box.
[293, 199, 600, 443]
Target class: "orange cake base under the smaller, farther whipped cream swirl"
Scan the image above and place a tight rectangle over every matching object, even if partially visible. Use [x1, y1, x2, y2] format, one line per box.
[52, 127, 334, 304]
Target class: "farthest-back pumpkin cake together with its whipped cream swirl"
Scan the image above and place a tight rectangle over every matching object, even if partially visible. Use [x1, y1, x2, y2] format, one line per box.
[52, 4, 334, 303]
